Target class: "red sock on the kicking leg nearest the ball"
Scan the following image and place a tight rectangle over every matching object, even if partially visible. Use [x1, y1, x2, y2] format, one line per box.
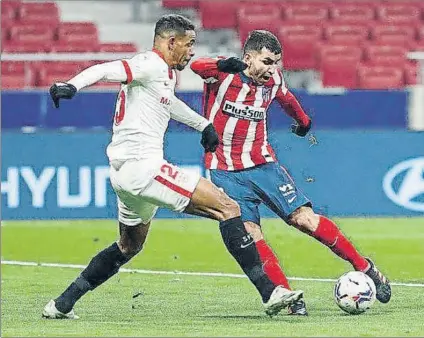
[311, 216, 369, 271]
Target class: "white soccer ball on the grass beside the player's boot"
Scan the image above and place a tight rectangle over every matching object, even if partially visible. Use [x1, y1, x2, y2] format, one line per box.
[334, 271, 376, 315]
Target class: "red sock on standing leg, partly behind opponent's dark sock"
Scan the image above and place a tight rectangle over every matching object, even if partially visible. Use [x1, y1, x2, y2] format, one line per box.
[255, 239, 291, 290]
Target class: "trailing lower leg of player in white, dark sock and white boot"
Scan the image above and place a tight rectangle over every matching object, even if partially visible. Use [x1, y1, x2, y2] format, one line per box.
[43, 222, 150, 319]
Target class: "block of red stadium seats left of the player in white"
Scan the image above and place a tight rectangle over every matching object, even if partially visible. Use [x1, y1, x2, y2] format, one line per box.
[1, 0, 137, 89]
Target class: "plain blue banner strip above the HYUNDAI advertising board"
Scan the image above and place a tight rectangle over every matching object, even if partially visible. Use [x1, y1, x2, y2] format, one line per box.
[1, 90, 408, 131]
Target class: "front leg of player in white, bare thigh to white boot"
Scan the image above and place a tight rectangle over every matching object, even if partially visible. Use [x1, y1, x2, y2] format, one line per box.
[185, 178, 303, 316]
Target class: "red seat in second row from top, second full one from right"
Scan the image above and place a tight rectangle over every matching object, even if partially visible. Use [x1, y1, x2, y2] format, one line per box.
[324, 24, 369, 46]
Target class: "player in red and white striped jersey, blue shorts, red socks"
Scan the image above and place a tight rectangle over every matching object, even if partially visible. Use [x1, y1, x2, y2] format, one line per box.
[191, 30, 391, 315]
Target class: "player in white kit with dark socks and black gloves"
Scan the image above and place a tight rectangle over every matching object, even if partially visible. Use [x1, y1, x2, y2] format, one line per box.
[43, 15, 303, 319]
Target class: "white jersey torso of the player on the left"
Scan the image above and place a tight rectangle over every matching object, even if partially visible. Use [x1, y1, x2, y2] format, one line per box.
[107, 51, 176, 161]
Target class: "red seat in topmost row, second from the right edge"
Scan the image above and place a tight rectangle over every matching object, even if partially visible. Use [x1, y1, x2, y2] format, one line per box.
[330, 5, 375, 25]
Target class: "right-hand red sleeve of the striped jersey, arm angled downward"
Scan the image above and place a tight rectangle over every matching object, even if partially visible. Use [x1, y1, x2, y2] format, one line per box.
[275, 71, 310, 126]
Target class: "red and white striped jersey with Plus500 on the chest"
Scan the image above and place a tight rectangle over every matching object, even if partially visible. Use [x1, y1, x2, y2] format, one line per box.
[191, 58, 309, 171]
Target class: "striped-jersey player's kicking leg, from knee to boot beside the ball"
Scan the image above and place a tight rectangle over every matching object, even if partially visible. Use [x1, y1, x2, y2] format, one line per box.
[289, 206, 392, 303]
